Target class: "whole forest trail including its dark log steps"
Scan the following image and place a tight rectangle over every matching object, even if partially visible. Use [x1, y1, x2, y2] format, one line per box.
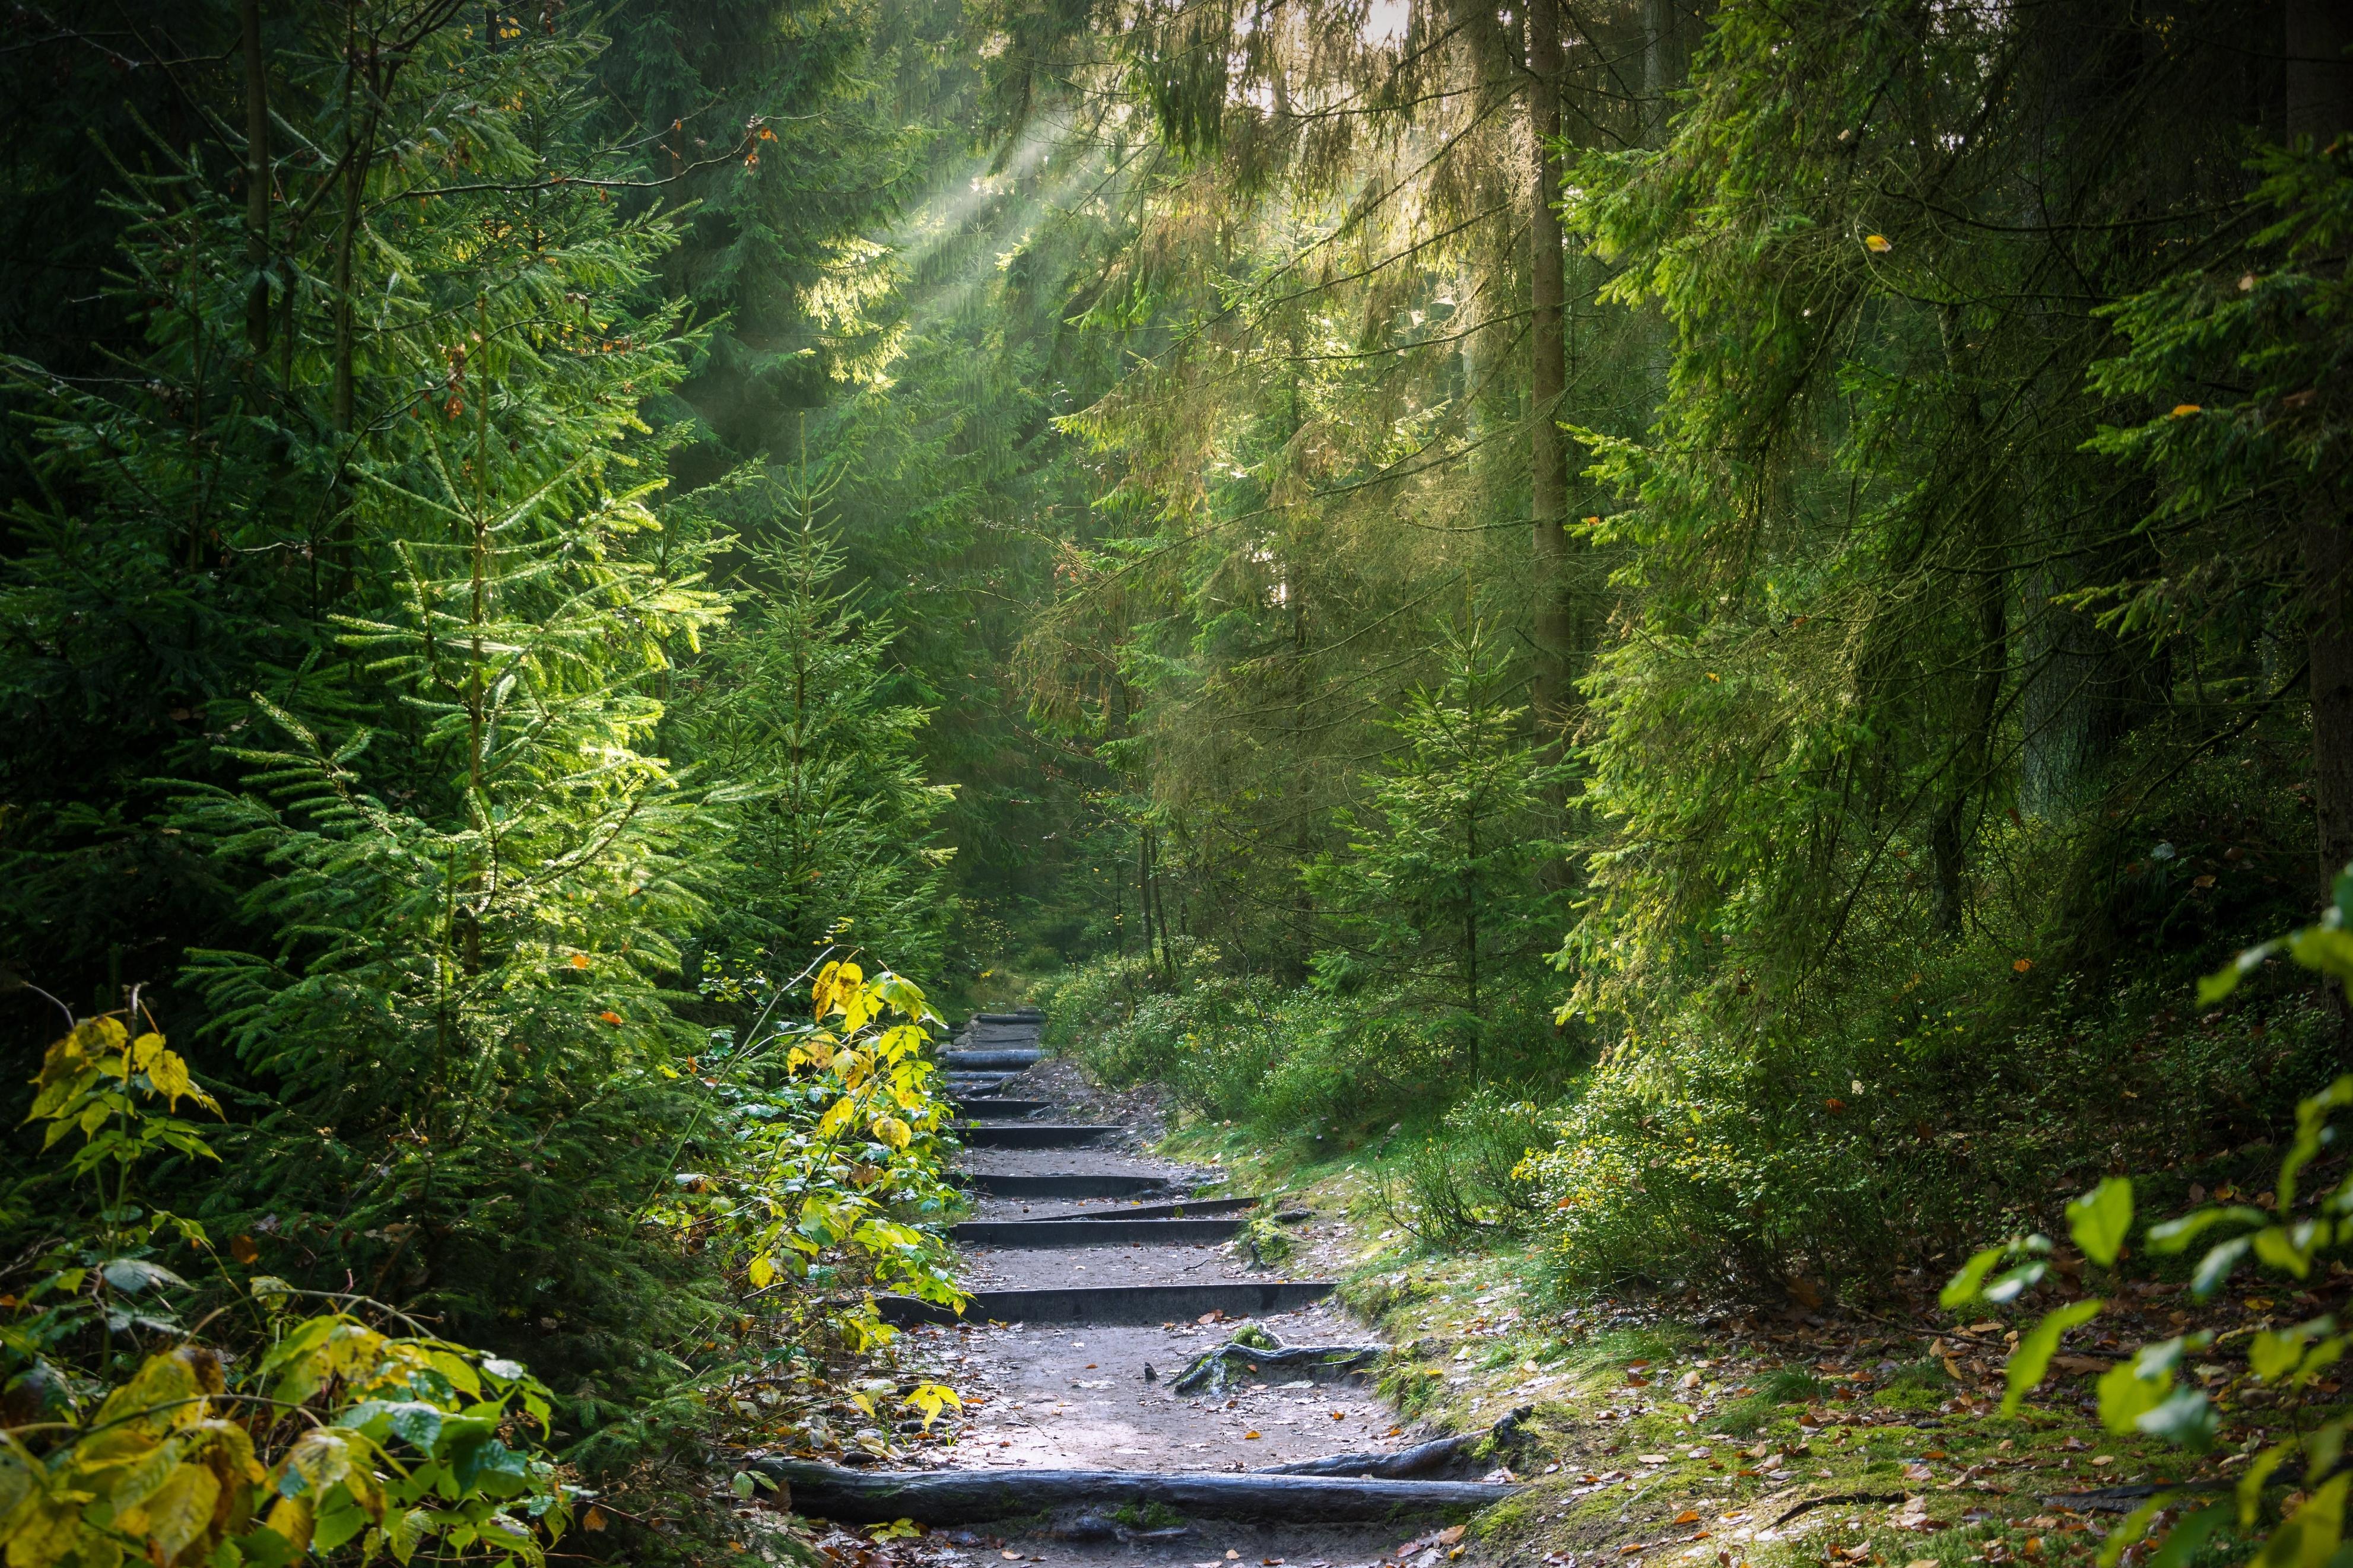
[770, 1013, 1509, 1568]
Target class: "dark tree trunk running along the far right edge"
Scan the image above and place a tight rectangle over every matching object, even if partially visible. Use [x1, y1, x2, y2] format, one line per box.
[2287, 0, 2353, 896]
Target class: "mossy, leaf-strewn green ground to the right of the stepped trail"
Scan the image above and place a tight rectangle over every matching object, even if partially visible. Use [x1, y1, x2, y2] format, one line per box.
[1167, 1126, 2341, 1568]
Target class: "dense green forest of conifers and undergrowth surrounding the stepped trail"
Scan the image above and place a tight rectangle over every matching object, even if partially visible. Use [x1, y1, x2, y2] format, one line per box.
[0, 0, 2353, 1568]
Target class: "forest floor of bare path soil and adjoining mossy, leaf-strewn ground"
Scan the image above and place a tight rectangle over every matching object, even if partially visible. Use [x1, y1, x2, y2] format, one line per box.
[757, 1063, 2334, 1568]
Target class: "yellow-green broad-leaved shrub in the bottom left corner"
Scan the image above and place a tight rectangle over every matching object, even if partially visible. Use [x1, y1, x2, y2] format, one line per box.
[0, 1016, 576, 1568]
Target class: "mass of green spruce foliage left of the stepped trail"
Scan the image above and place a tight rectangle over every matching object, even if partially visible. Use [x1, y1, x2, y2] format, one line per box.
[0, 0, 979, 1523]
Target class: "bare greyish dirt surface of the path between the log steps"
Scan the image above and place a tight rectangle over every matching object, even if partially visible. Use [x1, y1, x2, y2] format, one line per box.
[781, 1023, 1475, 1568]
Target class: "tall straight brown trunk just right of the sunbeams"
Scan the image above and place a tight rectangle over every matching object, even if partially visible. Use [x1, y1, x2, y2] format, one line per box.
[1527, 0, 1574, 733]
